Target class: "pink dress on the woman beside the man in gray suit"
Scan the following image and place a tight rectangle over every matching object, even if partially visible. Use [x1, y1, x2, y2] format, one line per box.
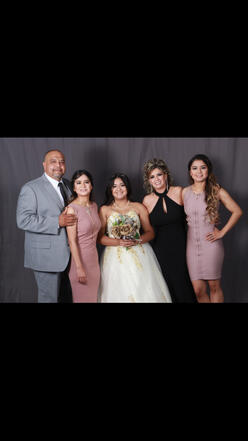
[69, 202, 101, 303]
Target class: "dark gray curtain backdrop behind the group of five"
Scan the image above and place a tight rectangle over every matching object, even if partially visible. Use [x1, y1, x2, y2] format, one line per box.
[0, 138, 248, 302]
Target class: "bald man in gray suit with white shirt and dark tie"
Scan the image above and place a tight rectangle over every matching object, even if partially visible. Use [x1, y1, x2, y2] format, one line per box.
[17, 150, 77, 303]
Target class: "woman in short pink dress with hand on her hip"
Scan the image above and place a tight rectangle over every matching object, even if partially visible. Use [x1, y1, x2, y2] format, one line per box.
[182, 154, 242, 303]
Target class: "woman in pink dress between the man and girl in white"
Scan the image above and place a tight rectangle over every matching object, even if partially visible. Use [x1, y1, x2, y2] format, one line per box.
[67, 170, 101, 303]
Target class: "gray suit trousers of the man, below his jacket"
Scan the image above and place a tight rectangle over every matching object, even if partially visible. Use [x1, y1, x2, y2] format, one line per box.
[34, 271, 61, 303]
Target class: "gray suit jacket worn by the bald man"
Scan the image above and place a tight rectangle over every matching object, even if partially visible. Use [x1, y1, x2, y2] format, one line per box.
[16, 175, 71, 272]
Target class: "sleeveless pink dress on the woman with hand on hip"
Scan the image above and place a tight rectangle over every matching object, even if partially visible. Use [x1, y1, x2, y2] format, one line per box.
[184, 187, 224, 280]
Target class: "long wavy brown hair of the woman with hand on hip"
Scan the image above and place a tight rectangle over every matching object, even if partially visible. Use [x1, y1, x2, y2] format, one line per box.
[188, 154, 221, 225]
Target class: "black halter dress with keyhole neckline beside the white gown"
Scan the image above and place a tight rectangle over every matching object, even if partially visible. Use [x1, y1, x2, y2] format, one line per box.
[150, 191, 197, 303]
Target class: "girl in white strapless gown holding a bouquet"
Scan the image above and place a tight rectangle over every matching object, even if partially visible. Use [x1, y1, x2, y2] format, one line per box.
[99, 174, 172, 303]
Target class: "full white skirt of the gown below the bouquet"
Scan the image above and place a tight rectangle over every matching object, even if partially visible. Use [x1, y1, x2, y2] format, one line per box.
[98, 243, 172, 303]
